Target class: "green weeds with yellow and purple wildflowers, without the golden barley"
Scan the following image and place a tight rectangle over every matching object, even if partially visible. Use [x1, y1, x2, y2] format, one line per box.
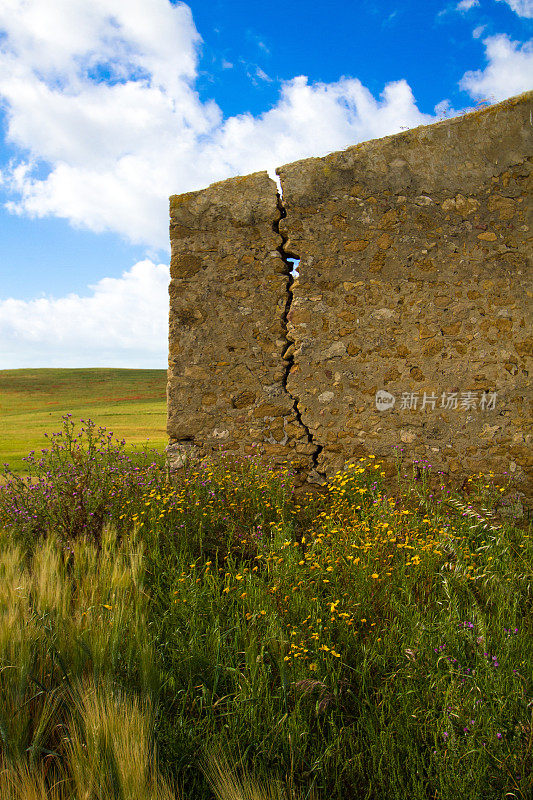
[0, 423, 533, 800]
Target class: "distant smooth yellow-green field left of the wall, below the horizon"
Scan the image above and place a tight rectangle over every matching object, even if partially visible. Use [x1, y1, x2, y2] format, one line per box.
[0, 369, 167, 472]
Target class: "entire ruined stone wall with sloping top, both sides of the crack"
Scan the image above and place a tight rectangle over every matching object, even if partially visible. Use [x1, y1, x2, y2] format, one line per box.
[168, 93, 533, 494]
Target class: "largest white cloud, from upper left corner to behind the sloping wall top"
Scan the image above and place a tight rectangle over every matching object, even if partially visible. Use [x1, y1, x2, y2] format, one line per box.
[0, 0, 432, 248]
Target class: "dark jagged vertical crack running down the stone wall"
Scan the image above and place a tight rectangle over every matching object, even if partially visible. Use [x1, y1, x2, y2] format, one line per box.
[272, 192, 326, 484]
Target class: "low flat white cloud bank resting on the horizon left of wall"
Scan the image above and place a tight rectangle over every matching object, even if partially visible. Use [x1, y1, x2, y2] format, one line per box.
[0, 260, 169, 369]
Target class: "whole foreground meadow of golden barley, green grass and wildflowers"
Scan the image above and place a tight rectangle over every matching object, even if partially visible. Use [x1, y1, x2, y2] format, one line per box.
[0, 413, 533, 800]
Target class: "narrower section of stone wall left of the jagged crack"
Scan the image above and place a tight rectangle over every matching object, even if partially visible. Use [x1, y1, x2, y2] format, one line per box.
[168, 172, 312, 478]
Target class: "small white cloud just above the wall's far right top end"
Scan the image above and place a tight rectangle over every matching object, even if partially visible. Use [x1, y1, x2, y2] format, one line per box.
[459, 34, 533, 102]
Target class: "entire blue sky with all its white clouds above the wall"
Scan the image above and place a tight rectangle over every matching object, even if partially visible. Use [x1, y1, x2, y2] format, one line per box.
[0, 0, 533, 369]
